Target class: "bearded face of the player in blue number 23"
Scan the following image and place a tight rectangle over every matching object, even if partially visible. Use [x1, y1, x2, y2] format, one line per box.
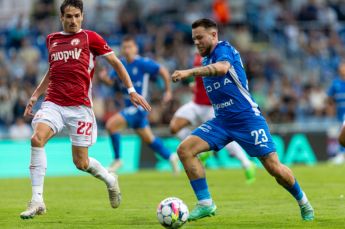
[192, 26, 215, 57]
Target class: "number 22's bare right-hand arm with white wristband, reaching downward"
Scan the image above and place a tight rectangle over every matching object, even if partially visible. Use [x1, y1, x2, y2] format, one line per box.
[105, 54, 151, 111]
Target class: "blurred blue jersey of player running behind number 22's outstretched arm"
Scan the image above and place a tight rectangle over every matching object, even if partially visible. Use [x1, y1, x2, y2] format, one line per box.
[110, 56, 160, 107]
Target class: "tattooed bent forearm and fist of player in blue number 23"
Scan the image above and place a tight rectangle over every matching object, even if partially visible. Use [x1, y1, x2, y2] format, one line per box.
[172, 61, 230, 82]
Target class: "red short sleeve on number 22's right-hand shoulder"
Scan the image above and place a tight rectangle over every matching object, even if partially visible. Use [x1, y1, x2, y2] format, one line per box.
[88, 31, 114, 56]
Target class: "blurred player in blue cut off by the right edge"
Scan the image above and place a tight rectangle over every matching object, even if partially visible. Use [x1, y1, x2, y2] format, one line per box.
[328, 60, 345, 164]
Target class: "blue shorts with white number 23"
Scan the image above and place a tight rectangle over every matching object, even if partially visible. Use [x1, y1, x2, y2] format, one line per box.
[192, 115, 276, 157]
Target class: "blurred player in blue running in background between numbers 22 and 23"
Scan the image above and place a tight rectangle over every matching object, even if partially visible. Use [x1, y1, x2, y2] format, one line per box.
[99, 36, 179, 173]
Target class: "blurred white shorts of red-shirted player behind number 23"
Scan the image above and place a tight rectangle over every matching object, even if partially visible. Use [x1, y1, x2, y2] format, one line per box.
[174, 101, 214, 126]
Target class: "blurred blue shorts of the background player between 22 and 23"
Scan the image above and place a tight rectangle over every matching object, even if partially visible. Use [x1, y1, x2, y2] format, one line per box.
[120, 106, 149, 129]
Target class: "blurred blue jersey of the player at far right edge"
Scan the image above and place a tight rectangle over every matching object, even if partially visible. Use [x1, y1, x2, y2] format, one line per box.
[328, 77, 345, 122]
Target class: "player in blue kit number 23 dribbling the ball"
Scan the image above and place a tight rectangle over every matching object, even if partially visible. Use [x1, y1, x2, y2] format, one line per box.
[172, 19, 314, 221]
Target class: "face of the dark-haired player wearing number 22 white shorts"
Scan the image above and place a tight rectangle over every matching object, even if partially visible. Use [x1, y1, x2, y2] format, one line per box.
[61, 6, 83, 33]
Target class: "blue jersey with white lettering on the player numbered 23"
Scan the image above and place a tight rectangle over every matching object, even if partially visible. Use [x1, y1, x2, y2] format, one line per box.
[203, 41, 260, 118]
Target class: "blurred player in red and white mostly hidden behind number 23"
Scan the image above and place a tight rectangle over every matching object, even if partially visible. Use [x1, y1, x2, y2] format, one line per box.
[170, 53, 255, 183]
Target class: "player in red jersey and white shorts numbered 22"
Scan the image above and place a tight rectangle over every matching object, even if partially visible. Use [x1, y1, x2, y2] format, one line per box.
[20, 0, 151, 219]
